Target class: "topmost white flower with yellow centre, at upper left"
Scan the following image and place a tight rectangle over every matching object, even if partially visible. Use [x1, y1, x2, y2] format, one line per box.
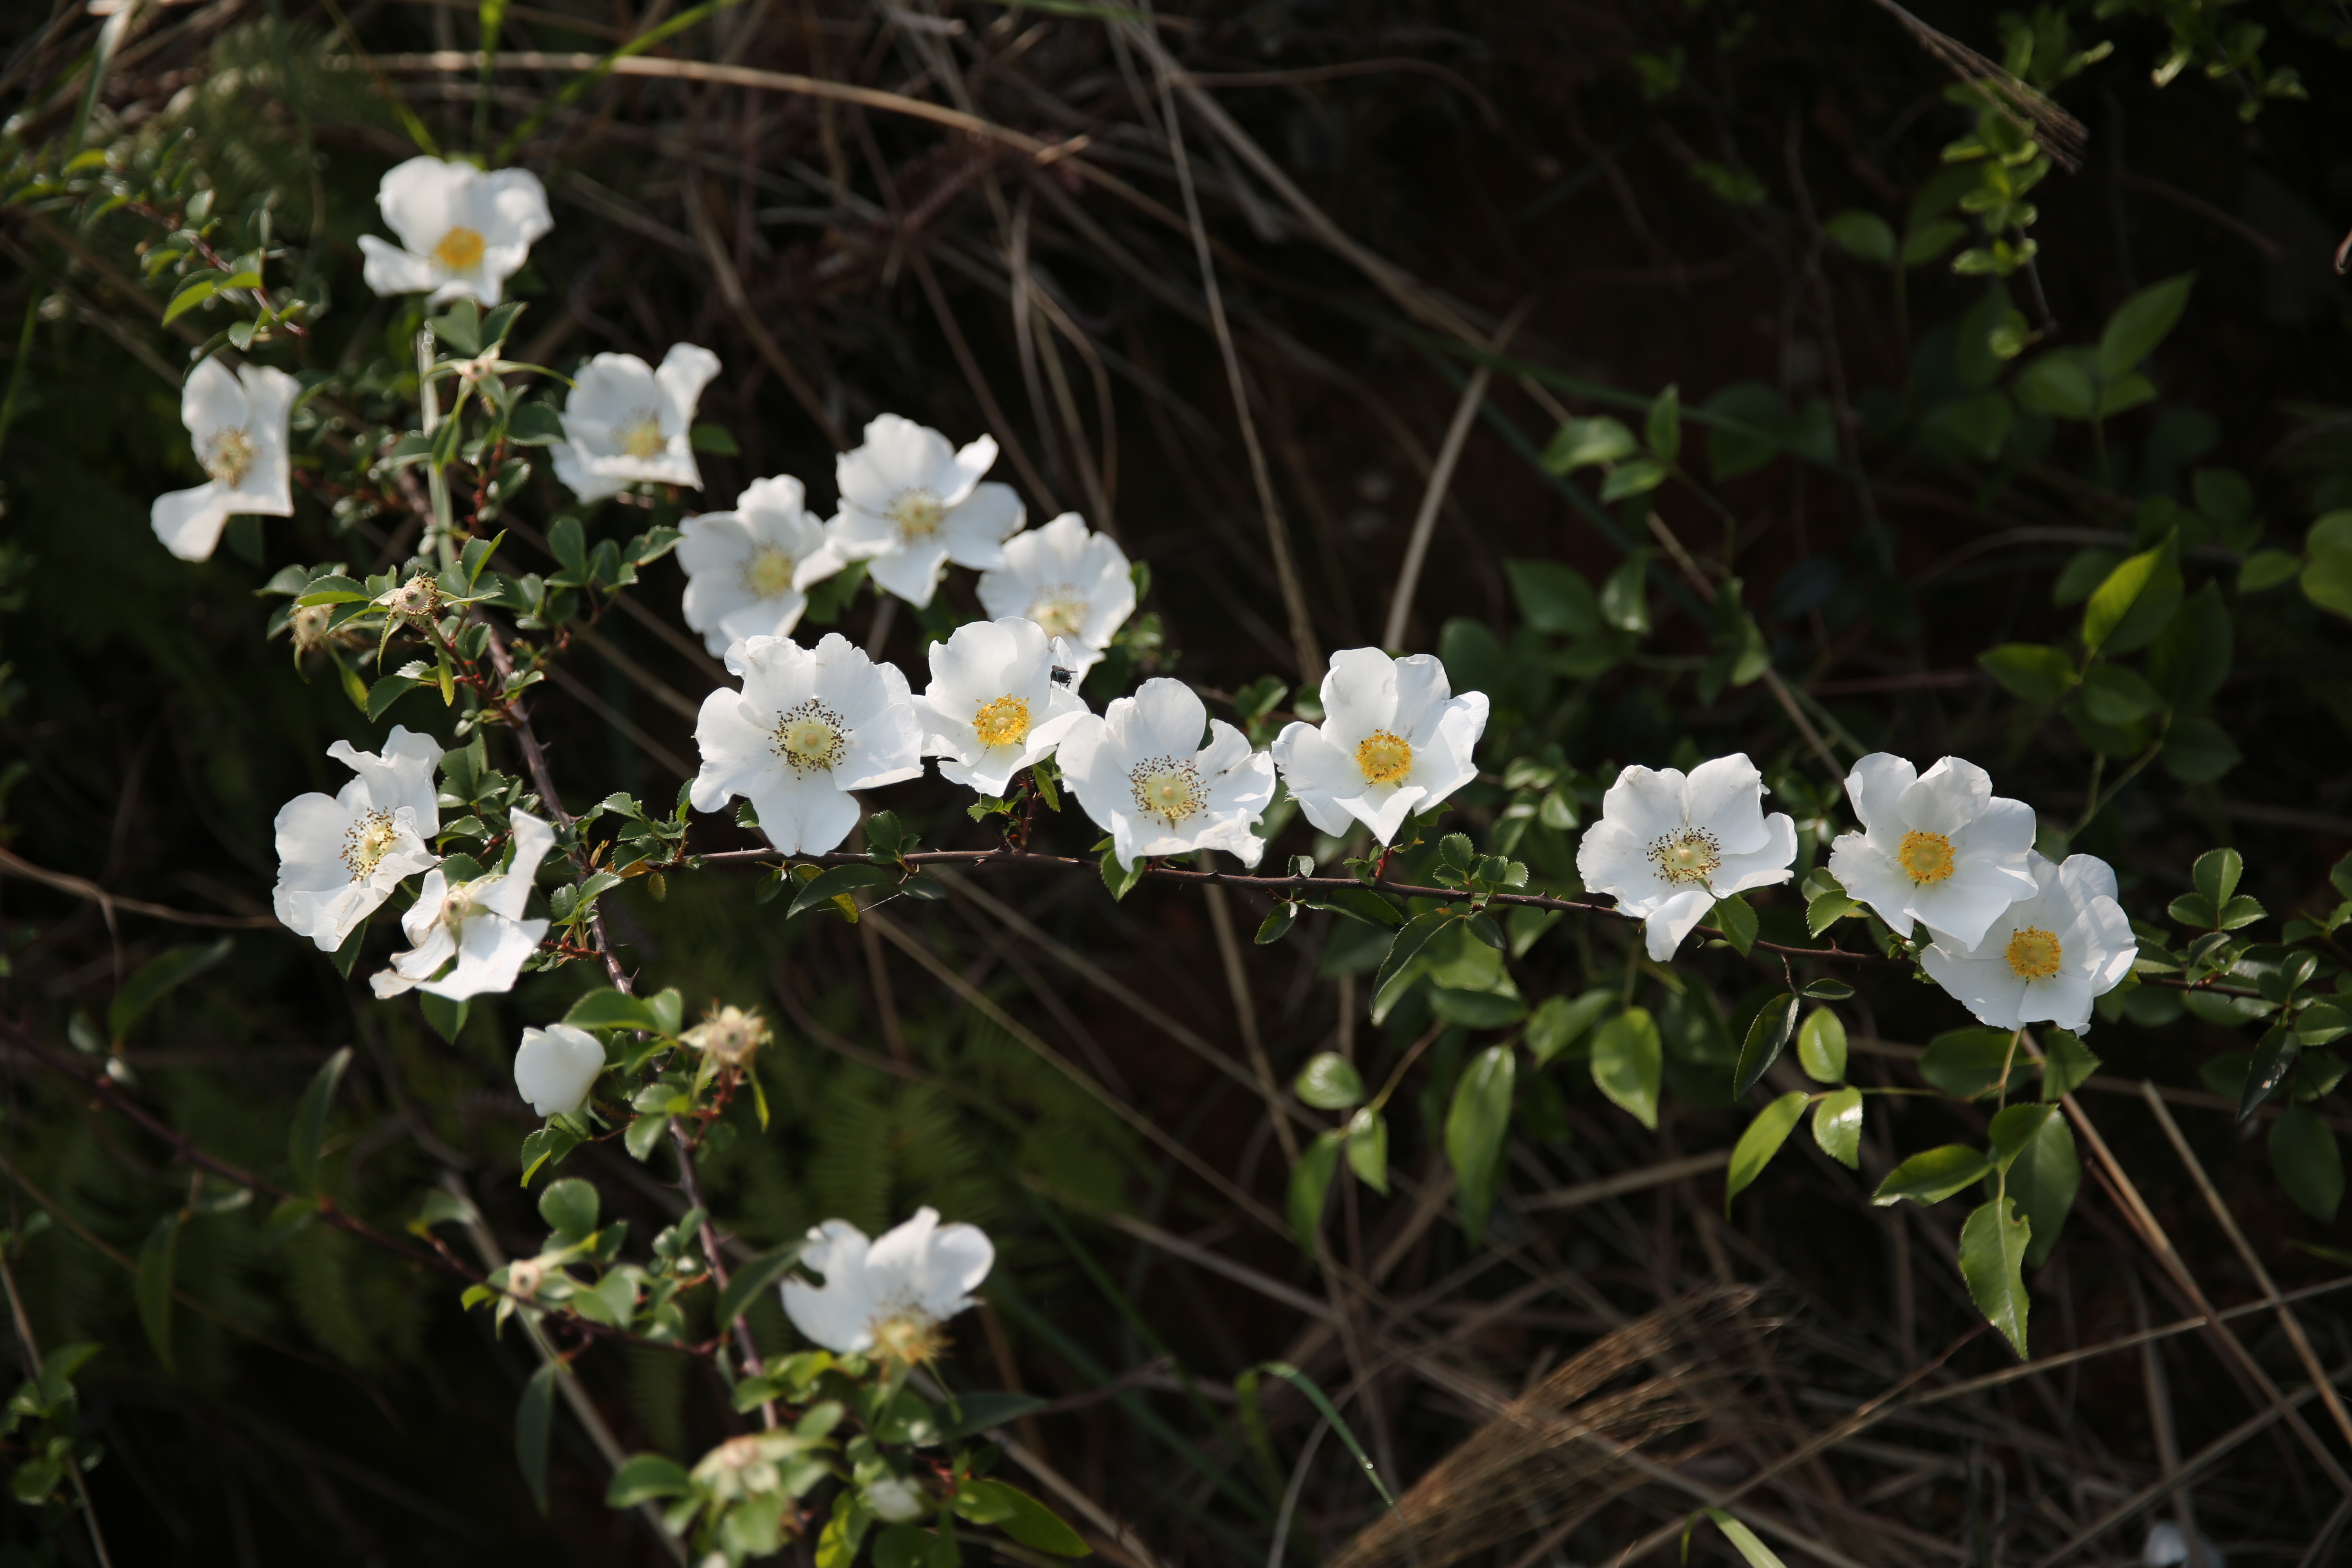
[360, 158, 555, 305]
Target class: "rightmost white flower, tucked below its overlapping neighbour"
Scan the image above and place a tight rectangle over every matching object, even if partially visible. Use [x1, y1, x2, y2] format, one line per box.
[1919, 853, 2140, 1030]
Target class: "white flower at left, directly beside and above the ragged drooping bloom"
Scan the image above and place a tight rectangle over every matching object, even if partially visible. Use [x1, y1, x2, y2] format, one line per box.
[270, 724, 442, 952]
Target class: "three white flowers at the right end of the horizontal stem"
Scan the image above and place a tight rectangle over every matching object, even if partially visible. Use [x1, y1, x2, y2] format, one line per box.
[1576, 752, 2138, 1030]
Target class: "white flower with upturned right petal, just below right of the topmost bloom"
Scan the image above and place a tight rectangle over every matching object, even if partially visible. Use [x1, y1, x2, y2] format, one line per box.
[548, 343, 720, 501]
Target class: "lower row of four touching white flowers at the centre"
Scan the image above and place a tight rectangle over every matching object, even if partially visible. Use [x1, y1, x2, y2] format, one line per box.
[691, 616, 1486, 867]
